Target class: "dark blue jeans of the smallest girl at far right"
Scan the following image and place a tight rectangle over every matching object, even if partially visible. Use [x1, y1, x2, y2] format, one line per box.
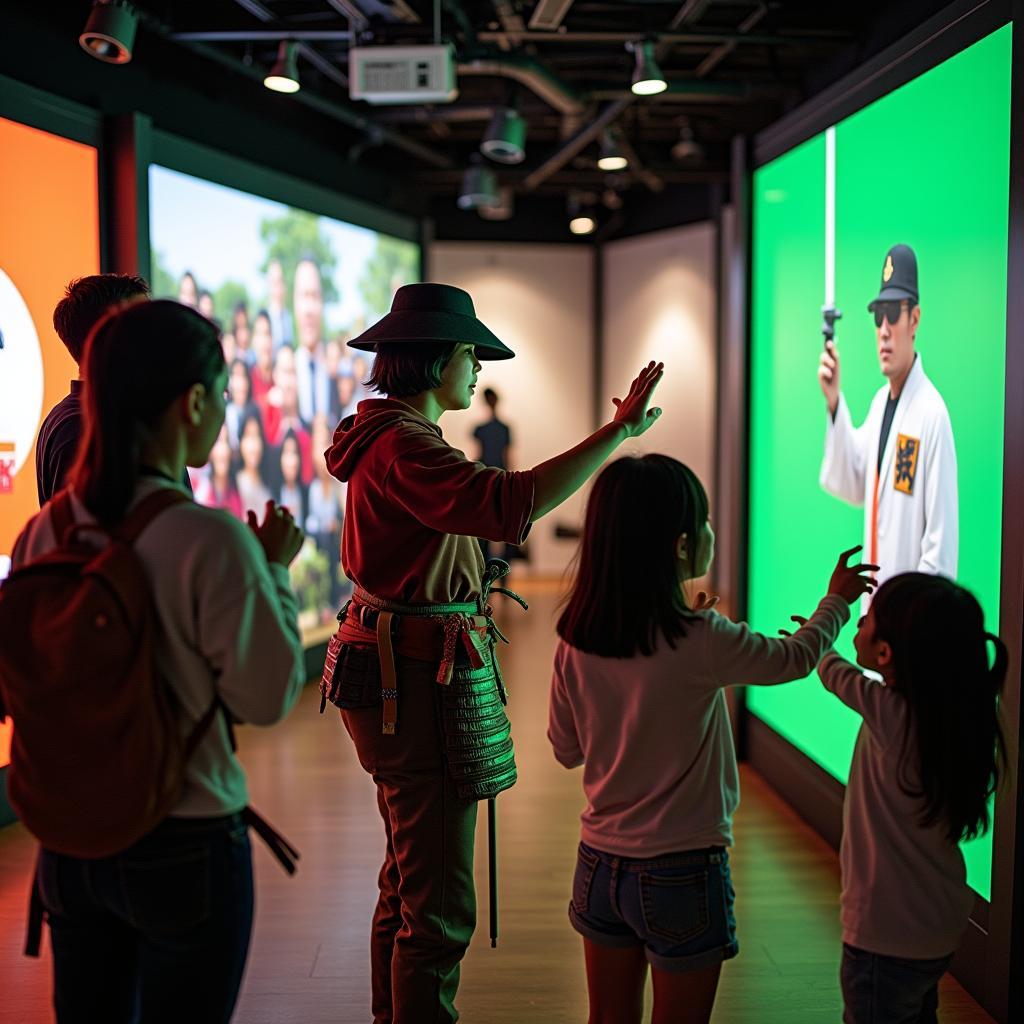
[840, 943, 952, 1024]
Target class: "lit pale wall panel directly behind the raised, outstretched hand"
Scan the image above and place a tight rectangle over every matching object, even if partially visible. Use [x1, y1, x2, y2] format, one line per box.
[601, 223, 718, 507]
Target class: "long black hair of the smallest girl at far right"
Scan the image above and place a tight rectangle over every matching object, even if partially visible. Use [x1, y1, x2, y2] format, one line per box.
[871, 572, 1008, 843]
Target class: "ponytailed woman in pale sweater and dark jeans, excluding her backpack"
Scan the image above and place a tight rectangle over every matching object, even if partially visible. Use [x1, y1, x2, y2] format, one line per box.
[14, 301, 305, 1024]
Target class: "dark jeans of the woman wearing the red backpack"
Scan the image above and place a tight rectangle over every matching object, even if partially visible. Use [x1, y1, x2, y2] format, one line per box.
[36, 815, 253, 1024]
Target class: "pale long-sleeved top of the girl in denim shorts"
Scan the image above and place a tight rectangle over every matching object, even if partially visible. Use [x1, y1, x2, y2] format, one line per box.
[548, 597, 850, 858]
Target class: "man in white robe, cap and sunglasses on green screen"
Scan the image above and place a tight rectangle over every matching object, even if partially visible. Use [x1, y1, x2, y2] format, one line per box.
[818, 245, 958, 598]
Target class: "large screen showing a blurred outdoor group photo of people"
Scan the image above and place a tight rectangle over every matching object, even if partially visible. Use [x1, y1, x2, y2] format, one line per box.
[150, 165, 420, 638]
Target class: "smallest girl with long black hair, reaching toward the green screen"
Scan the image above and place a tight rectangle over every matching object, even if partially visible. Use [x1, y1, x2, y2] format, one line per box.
[818, 572, 1007, 1024]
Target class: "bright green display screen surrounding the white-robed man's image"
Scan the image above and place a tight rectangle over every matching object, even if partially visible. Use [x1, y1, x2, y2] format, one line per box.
[748, 26, 1012, 899]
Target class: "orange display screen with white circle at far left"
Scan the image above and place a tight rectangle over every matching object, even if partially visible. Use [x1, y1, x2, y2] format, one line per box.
[0, 118, 99, 766]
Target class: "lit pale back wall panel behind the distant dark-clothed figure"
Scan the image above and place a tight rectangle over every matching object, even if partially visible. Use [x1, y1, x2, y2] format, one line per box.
[426, 243, 594, 575]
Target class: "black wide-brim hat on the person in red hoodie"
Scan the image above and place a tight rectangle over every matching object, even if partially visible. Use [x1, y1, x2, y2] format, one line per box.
[348, 284, 515, 359]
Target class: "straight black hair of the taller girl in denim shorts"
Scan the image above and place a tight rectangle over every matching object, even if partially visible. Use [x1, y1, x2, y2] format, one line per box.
[557, 455, 708, 657]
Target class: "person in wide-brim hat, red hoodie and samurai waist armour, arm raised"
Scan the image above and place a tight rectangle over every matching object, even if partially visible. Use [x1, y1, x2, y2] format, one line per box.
[322, 284, 663, 1024]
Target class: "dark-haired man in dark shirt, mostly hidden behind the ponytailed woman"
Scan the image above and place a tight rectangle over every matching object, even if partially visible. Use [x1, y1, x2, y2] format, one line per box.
[36, 273, 150, 508]
